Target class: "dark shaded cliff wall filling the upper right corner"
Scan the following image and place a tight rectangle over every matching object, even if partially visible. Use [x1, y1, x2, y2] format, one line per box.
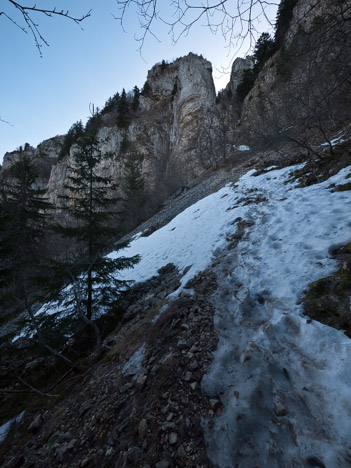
[240, 0, 351, 141]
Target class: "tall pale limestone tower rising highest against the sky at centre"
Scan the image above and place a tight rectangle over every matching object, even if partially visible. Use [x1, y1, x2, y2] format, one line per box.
[143, 53, 216, 183]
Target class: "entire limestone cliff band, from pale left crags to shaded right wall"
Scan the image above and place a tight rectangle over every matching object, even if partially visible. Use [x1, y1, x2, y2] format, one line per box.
[3, 0, 351, 207]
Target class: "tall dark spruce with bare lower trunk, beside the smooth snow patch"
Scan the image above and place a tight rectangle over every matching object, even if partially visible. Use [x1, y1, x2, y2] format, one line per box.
[53, 133, 138, 340]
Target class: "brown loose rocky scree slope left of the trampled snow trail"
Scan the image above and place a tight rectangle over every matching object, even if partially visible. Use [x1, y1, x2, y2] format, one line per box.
[0, 266, 221, 468]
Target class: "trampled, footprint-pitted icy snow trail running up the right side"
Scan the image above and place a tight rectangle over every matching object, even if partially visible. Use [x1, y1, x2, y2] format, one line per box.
[202, 168, 351, 468]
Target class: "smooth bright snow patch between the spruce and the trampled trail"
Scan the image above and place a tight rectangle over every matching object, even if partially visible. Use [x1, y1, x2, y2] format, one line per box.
[109, 186, 246, 292]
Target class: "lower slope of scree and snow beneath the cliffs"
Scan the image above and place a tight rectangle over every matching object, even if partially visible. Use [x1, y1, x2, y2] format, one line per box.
[0, 133, 351, 468]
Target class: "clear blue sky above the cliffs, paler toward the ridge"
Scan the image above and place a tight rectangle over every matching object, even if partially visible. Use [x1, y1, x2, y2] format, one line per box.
[0, 0, 275, 162]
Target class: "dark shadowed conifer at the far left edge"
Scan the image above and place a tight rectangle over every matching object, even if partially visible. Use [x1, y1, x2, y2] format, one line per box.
[0, 153, 51, 301]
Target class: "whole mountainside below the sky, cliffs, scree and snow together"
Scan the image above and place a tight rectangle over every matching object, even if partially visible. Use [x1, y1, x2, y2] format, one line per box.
[0, 0, 351, 468]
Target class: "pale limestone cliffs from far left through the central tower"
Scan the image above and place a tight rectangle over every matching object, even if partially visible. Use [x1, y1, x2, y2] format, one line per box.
[18, 53, 216, 204]
